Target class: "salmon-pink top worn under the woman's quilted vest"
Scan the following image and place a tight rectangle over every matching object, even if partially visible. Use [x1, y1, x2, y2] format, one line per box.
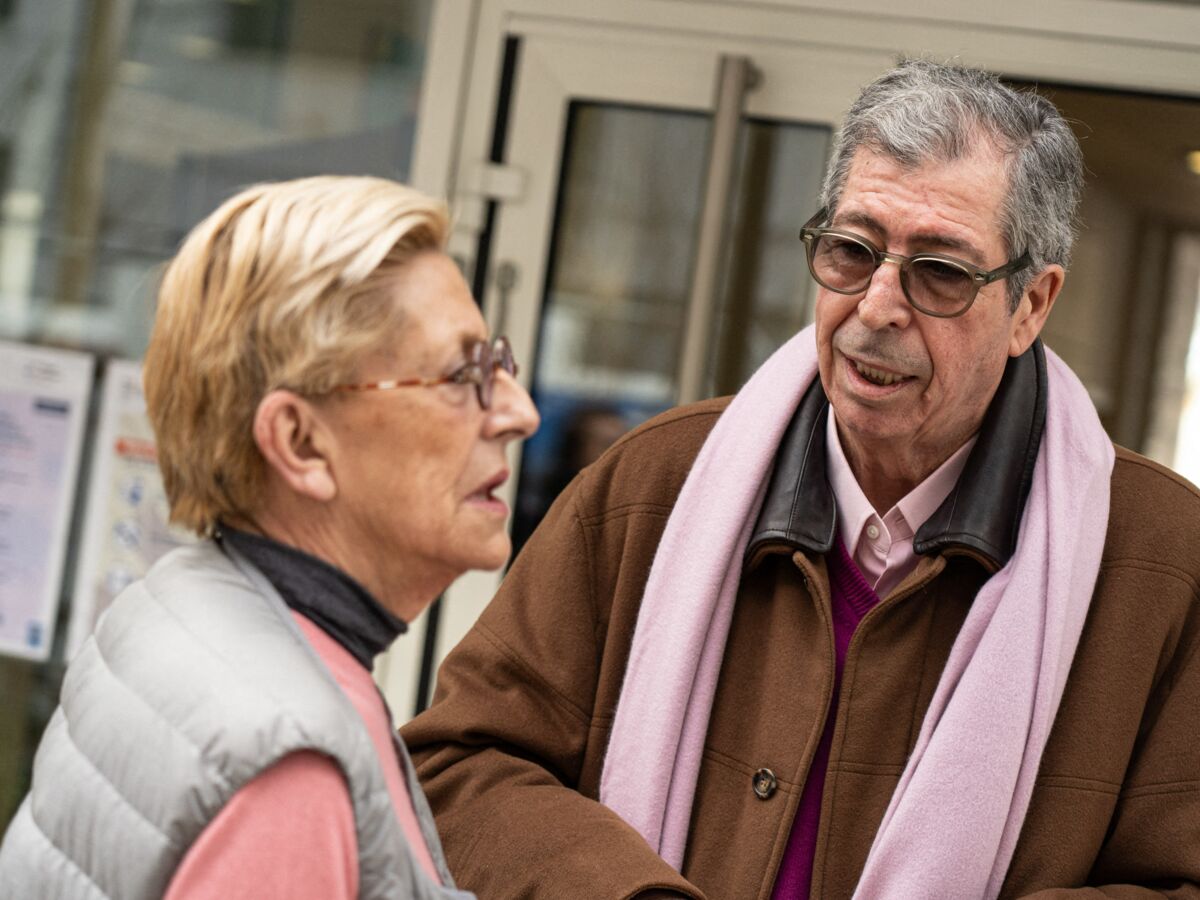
[164, 612, 442, 900]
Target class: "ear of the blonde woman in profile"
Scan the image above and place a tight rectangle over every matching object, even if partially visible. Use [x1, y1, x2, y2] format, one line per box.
[254, 390, 337, 503]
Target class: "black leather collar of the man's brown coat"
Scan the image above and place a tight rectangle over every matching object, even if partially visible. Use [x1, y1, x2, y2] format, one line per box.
[745, 340, 1046, 571]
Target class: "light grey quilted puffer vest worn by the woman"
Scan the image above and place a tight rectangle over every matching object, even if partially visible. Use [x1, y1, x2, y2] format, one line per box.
[0, 542, 472, 900]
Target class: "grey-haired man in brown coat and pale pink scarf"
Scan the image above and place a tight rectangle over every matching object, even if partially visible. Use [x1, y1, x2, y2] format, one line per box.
[404, 61, 1200, 900]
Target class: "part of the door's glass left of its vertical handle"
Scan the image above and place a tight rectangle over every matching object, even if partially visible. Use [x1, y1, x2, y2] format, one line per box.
[512, 102, 708, 548]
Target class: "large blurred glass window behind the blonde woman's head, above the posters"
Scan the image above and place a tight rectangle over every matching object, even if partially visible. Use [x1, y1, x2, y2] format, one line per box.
[0, 0, 430, 358]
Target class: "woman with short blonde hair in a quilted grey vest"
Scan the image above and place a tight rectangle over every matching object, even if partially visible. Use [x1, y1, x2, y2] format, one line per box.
[0, 178, 538, 900]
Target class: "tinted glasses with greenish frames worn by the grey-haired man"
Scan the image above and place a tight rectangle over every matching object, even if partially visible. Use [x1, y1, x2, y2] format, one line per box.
[800, 209, 1030, 319]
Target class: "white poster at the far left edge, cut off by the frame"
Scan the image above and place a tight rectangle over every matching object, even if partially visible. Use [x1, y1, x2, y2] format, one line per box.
[0, 341, 92, 660]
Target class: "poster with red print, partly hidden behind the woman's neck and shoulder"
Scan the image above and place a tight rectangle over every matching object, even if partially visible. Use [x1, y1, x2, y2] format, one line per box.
[67, 360, 191, 660]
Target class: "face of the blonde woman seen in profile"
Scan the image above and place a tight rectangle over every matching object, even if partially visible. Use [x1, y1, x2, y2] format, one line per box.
[328, 252, 539, 619]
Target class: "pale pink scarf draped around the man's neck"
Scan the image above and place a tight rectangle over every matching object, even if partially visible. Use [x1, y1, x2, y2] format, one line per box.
[600, 326, 1114, 898]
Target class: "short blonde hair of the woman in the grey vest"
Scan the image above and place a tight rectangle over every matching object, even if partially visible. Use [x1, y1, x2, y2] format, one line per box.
[143, 176, 449, 535]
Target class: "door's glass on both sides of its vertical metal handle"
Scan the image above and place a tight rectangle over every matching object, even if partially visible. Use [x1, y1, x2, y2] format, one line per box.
[514, 102, 829, 547]
